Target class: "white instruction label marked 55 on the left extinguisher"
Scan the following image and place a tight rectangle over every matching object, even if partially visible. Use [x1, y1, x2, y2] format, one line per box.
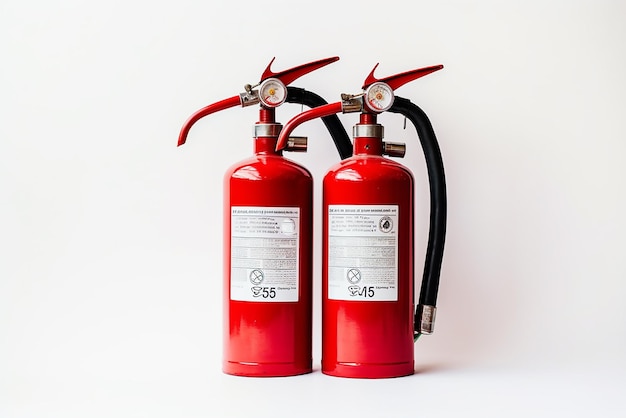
[230, 206, 300, 302]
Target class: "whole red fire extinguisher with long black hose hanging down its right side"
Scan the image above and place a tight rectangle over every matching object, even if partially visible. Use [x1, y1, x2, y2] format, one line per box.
[277, 65, 446, 378]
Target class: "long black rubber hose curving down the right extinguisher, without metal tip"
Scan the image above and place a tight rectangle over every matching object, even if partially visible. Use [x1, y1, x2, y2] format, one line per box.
[389, 96, 447, 306]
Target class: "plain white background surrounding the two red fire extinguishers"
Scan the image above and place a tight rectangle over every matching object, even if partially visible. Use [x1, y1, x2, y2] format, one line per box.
[0, 0, 626, 418]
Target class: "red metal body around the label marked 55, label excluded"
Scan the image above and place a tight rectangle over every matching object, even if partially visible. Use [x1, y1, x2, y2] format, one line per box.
[223, 127, 313, 376]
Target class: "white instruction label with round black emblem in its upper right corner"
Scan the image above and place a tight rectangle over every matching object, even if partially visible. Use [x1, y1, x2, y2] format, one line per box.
[328, 205, 398, 301]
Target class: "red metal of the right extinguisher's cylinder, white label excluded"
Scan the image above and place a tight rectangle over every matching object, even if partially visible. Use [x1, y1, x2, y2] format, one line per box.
[322, 115, 414, 378]
